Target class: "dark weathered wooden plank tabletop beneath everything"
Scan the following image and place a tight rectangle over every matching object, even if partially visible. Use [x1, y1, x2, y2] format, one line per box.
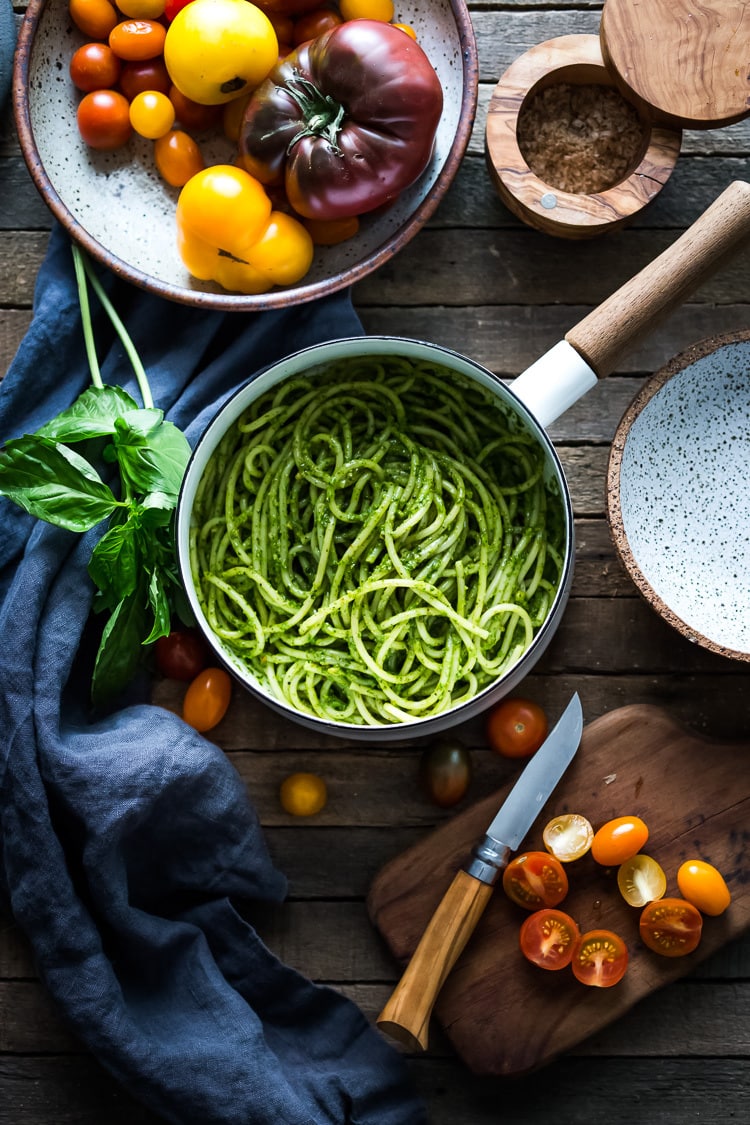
[0, 0, 750, 1125]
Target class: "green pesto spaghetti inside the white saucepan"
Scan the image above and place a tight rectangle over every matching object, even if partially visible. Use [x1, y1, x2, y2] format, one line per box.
[190, 357, 564, 726]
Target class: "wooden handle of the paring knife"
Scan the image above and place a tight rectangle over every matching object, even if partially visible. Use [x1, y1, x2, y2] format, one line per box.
[378, 871, 493, 1051]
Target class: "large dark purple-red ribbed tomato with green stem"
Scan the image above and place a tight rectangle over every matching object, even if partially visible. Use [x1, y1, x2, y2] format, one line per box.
[240, 20, 443, 219]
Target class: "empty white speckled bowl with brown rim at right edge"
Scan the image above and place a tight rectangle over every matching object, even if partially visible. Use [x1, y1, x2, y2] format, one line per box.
[607, 331, 750, 660]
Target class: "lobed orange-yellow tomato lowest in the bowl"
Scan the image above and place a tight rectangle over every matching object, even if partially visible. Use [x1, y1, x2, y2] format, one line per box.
[177, 164, 313, 294]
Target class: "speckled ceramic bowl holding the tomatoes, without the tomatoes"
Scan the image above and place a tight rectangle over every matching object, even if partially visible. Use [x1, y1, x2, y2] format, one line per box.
[13, 0, 478, 311]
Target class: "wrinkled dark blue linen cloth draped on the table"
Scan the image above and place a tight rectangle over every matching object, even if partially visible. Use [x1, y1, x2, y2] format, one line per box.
[0, 221, 425, 1125]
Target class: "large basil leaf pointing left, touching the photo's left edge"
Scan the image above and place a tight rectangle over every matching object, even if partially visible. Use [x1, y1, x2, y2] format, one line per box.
[0, 434, 118, 531]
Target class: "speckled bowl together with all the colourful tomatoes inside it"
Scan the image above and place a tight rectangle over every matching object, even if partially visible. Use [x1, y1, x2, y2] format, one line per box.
[13, 0, 478, 311]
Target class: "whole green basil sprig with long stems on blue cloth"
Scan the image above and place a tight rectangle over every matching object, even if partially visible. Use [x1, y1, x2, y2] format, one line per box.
[0, 246, 190, 705]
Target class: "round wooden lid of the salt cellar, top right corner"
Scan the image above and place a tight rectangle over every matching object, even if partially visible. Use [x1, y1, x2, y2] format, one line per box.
[599, 0, 750, 129]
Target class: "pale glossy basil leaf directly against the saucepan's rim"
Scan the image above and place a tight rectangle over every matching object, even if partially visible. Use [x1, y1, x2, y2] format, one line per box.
[112, 410, 190, 503]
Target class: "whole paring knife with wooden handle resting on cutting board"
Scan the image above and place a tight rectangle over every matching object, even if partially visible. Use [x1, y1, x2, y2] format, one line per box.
[378, 693, 584, 1051]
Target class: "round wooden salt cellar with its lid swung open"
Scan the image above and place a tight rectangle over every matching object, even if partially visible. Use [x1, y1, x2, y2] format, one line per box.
[486, 0, 750, 239]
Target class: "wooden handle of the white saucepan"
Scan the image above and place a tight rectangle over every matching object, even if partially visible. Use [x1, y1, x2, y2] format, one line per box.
[566, 180, 750, 379]
